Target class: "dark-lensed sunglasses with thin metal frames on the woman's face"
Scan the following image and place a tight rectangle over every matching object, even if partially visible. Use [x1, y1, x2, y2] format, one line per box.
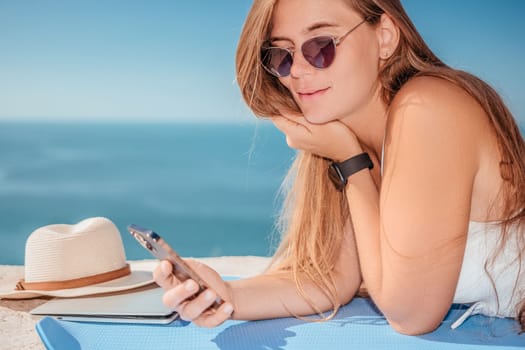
[261, 18, 366, 78]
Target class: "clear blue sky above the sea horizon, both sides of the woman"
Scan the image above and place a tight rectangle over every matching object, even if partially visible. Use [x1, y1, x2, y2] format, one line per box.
[0, 0, 525, 125]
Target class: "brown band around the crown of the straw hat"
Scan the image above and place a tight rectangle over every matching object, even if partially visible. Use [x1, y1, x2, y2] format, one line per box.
[15, 264, 131, 290]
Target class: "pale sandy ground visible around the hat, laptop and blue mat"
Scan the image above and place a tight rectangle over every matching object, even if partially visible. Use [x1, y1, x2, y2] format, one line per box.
[0, 256, 270, 350]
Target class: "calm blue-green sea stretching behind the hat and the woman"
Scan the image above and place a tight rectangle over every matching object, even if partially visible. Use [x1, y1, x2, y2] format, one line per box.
[0, 123, 294, 264]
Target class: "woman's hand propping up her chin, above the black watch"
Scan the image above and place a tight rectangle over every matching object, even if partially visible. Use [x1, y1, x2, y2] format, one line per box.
[271, 113, 362, 161]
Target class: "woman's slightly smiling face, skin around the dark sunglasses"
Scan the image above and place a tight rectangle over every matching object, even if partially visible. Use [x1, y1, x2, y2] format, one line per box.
[271, 0, 379, 123]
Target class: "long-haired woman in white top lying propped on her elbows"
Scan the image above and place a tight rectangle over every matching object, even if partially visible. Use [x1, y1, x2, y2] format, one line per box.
[155, 0, 525, 334]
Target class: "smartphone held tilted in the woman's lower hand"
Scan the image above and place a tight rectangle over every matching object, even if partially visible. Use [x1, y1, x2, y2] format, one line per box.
[128, 224, 223, 307]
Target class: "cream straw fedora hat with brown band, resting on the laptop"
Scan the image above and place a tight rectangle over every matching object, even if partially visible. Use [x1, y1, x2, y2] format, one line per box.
[0, 217, 153, 299]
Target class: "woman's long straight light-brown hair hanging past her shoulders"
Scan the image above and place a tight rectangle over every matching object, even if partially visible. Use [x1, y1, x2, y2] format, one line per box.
[236, 0, 525, 331]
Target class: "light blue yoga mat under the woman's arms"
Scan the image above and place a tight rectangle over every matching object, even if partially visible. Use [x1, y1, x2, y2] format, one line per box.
[36, 298, 525, 350]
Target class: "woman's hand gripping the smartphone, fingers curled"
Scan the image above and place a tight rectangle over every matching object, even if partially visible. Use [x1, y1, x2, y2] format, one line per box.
[153, 260, 233, 327]
